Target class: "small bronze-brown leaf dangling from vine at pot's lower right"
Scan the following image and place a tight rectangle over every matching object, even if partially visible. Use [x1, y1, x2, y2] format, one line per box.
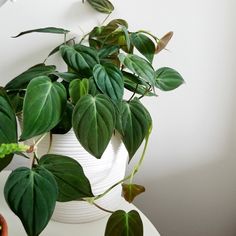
[122, 184, 145, 203]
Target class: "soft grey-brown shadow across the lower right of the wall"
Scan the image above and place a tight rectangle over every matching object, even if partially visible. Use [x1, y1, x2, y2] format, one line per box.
[135, 155, 236, 236]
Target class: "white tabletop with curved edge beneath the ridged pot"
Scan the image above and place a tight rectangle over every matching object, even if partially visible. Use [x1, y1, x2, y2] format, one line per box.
[0, 171, 160, 236]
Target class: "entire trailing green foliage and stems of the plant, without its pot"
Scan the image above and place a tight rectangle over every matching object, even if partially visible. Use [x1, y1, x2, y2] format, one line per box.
[0, 0, 184, 236]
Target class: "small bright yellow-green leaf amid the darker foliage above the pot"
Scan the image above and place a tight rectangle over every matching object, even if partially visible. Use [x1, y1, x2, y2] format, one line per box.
[69, 79, 89, 104]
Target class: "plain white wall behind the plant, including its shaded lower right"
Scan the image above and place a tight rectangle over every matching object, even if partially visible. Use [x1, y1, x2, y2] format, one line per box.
[0, 0, 236, 236]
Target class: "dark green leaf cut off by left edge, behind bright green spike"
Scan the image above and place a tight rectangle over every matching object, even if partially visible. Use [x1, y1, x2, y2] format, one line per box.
[0, 95, 17, 171]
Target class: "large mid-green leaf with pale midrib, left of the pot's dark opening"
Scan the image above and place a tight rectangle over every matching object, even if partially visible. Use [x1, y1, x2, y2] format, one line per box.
[21, 76, 67, 141]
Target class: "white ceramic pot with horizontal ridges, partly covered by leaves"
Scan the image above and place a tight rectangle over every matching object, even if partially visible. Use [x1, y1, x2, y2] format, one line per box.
[38, 130, 128, 223]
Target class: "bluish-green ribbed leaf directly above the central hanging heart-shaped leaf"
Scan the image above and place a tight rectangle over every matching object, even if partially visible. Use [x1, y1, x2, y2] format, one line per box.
[93, 64, 124, 101]
